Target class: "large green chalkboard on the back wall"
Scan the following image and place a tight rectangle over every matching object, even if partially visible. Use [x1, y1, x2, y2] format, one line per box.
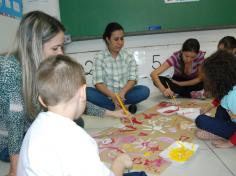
[59, 0, 236, 40]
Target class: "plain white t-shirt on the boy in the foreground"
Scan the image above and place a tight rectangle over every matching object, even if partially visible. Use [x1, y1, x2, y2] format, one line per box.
[17, 112, 114, 176]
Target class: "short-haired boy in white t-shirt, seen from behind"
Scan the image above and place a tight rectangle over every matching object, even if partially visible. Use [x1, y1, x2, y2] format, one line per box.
[17, 55, 132, 176]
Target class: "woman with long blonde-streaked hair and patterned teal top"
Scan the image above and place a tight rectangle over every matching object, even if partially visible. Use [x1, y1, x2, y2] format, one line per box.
[0, 11, 127, 176]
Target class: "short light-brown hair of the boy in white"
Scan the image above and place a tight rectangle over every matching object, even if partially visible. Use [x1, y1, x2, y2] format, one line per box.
[36, 55, 86, 106]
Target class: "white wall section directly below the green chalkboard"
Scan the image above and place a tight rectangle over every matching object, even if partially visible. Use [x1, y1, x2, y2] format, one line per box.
[66, 29, 236, 92]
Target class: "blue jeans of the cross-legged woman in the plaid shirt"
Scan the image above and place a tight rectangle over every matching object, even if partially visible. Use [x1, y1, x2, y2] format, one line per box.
[86, 85, 150, 111]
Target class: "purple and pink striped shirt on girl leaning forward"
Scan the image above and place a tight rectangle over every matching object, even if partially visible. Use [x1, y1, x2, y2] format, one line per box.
[166, 51, 206, 79]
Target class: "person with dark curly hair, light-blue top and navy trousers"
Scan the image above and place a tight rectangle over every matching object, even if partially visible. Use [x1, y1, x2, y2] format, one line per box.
[196, 50, 236, 147]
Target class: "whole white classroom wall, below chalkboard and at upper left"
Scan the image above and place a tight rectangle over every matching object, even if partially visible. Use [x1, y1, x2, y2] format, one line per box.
[0, 0, 236, 95]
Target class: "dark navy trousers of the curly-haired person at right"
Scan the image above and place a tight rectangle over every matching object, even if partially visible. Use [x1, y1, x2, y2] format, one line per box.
[195, 106, 236, 139]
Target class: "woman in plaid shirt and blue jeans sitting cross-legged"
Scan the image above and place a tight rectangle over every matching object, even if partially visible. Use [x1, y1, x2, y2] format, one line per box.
[87, 23, 150, 113]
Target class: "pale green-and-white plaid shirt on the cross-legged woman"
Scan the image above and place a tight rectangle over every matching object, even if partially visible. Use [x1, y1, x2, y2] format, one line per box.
[93, 50, 138, 93]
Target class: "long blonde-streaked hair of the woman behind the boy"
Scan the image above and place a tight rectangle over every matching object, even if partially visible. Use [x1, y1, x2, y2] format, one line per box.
[8, 11, 65, 117]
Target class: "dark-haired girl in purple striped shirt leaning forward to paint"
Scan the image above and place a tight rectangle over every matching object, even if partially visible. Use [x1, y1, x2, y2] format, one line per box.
[150, 38, 205, 97]
